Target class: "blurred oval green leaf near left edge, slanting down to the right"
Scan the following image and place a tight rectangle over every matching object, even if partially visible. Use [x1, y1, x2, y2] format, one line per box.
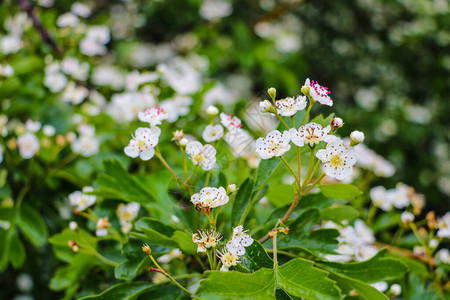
[17, 205, 48, 246]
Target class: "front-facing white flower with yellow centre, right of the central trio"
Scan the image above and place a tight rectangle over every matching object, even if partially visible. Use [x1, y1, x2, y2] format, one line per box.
[316, 139, 356, 180]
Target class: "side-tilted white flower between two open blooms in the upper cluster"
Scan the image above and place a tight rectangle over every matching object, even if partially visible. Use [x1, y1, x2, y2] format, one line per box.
[289, 122, 336, 147]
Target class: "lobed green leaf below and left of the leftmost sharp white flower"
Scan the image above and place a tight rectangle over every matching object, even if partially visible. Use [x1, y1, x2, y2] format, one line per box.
[93, 159, 155, 204]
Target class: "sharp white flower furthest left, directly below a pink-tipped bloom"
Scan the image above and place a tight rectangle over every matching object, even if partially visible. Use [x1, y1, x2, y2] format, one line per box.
[124, 127, 161, 160]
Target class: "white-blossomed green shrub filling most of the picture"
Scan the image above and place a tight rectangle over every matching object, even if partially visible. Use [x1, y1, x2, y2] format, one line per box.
[0, 0, 450, 299]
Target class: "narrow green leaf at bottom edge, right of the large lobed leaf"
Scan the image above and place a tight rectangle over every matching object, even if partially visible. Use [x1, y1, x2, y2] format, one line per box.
[330, 273, 389, 300]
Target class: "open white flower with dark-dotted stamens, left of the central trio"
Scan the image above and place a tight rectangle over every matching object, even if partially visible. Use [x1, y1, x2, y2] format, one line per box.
[256, 130, 291, 159]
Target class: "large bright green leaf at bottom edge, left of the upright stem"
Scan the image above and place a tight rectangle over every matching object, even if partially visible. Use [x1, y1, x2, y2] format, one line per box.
[195, 268, 276, 300]
